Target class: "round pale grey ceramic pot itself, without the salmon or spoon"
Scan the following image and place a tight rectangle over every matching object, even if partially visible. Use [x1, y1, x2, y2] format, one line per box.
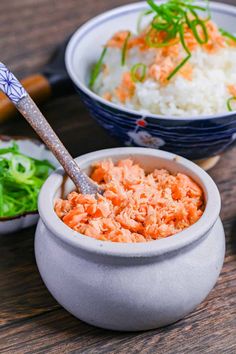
[35, 148, 225, 331]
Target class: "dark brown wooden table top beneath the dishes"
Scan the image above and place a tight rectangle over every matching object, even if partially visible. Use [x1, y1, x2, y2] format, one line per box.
[0, 0, 236, 354]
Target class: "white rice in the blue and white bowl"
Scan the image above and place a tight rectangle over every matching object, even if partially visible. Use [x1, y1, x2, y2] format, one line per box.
[94, 47, 236, 117]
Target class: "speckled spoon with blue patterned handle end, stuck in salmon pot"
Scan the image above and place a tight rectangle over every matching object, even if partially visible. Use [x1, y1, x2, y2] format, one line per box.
[0, 62, 102, 194]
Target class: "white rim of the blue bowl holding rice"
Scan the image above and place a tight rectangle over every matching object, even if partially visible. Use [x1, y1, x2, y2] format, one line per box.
[65, 0, 236, 121]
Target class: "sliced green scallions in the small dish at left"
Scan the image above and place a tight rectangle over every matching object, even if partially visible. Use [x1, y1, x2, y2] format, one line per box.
[0, 142, 54, 218]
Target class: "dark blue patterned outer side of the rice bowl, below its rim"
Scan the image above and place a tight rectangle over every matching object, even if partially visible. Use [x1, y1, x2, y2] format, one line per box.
[77, 88, 236, 160]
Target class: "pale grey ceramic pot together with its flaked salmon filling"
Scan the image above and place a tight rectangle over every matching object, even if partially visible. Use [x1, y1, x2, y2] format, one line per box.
[35, 147, 225, 331]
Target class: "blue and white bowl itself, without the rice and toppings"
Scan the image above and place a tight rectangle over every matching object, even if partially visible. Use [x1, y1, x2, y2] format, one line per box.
[65, 2, 236, 159]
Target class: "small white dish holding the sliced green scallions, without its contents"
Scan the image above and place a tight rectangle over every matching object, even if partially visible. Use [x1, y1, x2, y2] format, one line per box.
[0, 135, 59, 234]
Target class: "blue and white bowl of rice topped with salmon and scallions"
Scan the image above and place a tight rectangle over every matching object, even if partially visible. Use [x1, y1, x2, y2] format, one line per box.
[65, 0, 236, 160]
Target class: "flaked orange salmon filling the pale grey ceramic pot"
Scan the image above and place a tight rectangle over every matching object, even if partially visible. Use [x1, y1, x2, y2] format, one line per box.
[55, 159, 204, 242]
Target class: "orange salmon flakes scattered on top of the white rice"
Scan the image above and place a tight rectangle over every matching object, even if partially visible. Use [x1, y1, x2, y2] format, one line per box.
[106, 20, 230, 90]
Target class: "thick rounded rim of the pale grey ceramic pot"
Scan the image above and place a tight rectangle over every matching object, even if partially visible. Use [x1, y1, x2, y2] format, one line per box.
[38, 147, 221, 258]
